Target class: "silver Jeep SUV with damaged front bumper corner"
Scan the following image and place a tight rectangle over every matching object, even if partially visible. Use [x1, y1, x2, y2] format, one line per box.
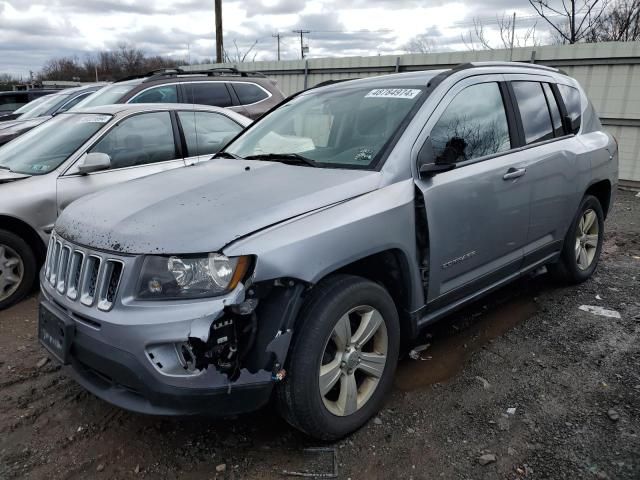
[39, 63, 618, 439]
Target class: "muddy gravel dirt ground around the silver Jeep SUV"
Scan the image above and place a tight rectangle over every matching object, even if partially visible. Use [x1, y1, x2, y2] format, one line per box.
[0, 192, 640, 480]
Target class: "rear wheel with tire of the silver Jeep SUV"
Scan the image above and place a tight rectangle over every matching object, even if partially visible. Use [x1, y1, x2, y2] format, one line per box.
[550, 195, 604, 284]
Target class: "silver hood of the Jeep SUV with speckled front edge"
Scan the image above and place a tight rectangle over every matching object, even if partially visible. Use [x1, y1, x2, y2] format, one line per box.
[55, 159, 382, 254]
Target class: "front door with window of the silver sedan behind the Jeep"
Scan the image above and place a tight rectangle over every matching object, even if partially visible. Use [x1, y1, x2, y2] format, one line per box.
[57, 112, 185, 213]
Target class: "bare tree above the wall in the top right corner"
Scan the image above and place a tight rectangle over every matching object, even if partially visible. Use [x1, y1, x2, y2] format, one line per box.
[586, 0, 640, 42]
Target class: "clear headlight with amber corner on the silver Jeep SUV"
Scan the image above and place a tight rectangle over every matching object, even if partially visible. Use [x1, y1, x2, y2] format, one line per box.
[137, 253, 251, 300]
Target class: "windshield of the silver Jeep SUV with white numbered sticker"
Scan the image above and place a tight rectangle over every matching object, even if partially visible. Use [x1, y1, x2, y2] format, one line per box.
[226, 87, 424, 169]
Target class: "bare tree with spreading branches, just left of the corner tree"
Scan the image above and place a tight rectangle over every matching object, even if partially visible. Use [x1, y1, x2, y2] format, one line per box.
[529, 0, 609, 44]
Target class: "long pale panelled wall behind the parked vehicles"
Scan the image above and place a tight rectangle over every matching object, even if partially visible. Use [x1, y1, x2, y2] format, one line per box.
[185, 42, 640, 185]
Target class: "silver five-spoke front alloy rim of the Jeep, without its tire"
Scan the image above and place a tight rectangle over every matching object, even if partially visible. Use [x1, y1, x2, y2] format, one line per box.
[319, 305, 389, 417]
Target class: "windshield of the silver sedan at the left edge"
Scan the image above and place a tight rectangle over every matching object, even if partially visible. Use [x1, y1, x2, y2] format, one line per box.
[0, 113, 111, 175]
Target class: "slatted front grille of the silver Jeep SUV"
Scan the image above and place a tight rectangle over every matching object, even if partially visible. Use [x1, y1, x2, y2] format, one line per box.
[44, 232, 125, 311]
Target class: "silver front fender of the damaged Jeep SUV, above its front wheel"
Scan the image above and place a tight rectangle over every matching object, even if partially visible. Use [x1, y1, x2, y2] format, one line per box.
[224, 179, 424, 309]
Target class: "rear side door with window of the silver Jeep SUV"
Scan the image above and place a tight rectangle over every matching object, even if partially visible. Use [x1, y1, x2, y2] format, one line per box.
[505, 75, 583, 265]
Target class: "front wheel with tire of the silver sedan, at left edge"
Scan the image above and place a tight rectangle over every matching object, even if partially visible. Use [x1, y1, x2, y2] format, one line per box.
[0, 230, 38, 310]
